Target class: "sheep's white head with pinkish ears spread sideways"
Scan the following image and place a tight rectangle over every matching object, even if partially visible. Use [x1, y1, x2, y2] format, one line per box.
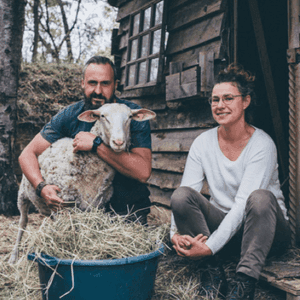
[78, 103, 155, 152]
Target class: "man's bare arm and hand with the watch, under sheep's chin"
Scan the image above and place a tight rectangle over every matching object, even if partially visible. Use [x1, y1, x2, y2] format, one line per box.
[73, 132, 152, 182]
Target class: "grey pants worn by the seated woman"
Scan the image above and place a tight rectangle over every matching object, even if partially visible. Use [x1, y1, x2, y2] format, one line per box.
[171, 187, 290, 279]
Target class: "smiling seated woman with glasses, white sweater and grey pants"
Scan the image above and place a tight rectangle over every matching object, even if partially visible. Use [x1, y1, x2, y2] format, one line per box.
[171, 65, 290, 299]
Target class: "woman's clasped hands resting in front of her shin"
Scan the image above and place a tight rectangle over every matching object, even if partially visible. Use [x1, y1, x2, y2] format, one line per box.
[172, 234, 212, 260]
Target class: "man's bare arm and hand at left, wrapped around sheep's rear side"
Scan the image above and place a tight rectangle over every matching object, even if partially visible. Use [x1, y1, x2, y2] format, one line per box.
[19, 133, 63, 209]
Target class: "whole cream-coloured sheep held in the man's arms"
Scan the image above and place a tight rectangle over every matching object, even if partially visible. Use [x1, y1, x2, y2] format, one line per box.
[9, 103, 155, 264]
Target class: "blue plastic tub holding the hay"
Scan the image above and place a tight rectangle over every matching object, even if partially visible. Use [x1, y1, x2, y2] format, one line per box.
[28, 245, 164, 300]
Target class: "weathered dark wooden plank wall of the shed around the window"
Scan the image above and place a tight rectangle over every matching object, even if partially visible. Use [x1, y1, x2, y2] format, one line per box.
[110, 0, 231, 217]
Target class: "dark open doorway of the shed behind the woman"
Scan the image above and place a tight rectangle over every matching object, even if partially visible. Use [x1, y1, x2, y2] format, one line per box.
[237, 0, 289, 199]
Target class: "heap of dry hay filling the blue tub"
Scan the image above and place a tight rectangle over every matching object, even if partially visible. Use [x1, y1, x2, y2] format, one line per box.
[26, 208, 168, 260]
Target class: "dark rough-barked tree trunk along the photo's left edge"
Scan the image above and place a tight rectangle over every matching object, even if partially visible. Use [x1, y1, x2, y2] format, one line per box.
[0, 0, 26, 216]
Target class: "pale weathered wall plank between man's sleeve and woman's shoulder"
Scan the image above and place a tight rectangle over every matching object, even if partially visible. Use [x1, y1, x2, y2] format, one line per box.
[151, 129, 207, 152]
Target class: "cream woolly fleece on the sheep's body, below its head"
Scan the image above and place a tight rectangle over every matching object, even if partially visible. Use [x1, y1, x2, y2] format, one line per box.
[18, 138, 115, 215]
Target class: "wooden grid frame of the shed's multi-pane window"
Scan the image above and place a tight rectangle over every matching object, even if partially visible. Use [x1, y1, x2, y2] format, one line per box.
[124, 0, 166, 90]
